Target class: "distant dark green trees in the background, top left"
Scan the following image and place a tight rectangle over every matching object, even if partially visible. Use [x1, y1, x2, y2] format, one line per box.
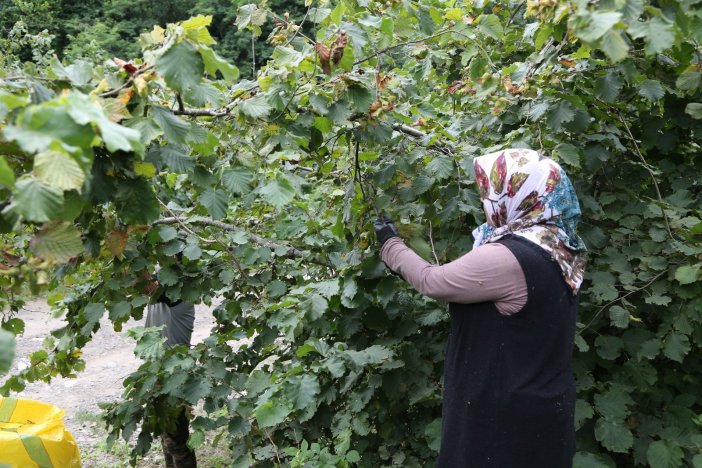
[0, 0, 311, 77]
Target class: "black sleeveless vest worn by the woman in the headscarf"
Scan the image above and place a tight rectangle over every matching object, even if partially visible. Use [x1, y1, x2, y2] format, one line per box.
[438, 236, 578, 468]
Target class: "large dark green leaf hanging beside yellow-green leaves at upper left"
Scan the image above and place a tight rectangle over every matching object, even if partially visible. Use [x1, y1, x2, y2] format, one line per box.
[154, 41, 205, 95]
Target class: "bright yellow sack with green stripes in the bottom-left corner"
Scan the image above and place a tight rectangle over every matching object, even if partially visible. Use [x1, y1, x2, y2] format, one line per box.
[0, 397, 81, 468]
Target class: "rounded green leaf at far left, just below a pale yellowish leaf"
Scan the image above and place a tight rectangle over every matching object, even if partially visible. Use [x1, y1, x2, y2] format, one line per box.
[13, 176, 63, 222]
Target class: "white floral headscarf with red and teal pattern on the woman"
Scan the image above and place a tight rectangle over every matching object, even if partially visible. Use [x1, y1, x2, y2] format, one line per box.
[473, 148, 587, 294]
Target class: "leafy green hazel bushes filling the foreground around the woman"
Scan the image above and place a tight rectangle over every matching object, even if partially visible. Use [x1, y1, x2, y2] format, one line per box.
[0, 0, 702, 467]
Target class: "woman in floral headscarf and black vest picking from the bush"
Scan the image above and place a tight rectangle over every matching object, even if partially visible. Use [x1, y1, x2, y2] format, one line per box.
[375, 149, 585, 468]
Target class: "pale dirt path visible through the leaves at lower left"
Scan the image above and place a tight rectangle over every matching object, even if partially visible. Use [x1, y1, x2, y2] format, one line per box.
[7, 301, 214, 466]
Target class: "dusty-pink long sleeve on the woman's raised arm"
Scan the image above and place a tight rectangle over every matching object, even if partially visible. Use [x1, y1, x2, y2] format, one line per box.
[380, 237, 527, 315]
